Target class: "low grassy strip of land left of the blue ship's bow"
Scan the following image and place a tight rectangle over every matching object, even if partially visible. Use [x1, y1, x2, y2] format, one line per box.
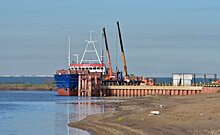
[0, 84, 56, 91]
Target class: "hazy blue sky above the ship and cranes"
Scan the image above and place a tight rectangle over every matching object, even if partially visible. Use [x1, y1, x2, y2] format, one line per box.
[0, 0, 220, 76]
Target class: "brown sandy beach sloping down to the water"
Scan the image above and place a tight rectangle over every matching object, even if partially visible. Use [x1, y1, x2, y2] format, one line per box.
[69, 94, 220, 135]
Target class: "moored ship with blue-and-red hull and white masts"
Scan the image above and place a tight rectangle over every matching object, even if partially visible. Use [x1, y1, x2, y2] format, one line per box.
[54, 32, 105, 96]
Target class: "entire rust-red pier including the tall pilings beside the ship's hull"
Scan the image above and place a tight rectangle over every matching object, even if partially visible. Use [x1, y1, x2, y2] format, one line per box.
[78, 75, 220, 97]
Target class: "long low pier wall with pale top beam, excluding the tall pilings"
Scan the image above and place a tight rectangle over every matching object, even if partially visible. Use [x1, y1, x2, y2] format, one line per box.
[101, 86, 202, 97]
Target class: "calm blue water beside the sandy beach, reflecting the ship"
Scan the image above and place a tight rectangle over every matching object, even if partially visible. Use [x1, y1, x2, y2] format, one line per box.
[0, 91, 114, 135]
